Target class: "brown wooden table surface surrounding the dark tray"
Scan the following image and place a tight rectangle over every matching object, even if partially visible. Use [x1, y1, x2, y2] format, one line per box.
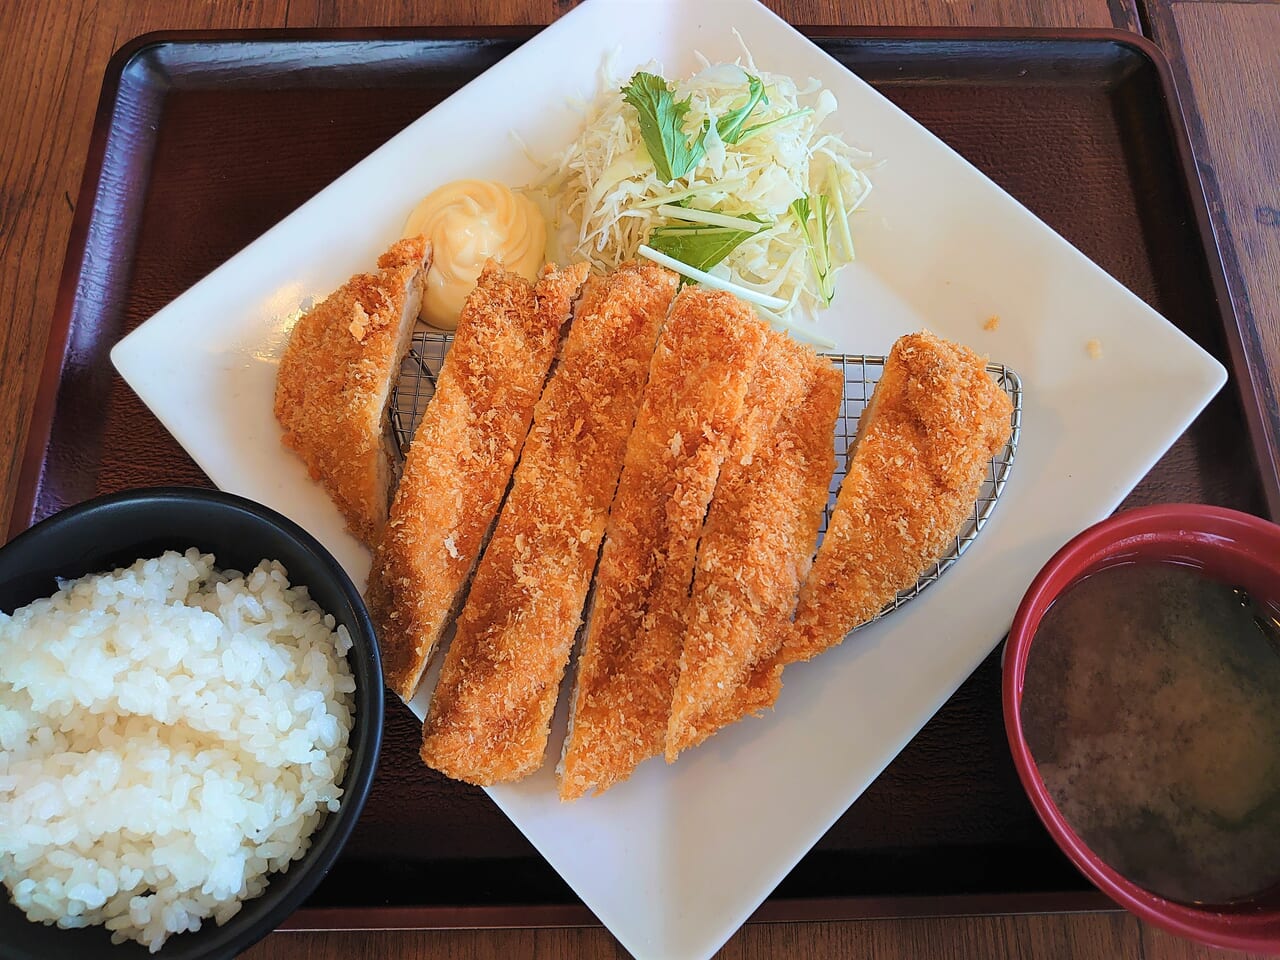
[0, 0, 1280, 960]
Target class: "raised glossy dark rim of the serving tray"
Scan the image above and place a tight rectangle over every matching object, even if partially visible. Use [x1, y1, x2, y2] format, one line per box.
[6, 24, 1249, 931]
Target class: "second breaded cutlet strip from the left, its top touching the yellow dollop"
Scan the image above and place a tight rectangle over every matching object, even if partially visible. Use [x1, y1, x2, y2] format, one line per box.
[366, 261, 586, 700]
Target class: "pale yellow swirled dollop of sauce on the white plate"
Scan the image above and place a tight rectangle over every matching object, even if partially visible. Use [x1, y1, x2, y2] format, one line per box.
[404, 180, 547, 330]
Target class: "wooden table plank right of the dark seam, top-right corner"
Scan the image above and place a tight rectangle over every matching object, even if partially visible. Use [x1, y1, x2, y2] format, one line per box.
[1152, 0, 1280, 519]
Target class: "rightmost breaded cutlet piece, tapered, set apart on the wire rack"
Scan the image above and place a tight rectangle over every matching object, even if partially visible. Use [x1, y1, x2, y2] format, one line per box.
[781, 333, 1012, 664]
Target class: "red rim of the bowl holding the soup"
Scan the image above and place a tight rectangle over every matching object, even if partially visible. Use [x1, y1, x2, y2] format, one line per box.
[1001, 503, 1280, 952]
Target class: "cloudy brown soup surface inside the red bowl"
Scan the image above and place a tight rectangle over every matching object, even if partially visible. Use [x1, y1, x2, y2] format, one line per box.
[1021, 563, 1280, 904]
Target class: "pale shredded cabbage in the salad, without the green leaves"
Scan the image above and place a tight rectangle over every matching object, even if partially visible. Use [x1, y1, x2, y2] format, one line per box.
[526, 46, 872, 326]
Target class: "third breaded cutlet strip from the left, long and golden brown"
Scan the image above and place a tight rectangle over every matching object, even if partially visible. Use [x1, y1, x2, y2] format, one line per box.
[421, 264, 677, 786]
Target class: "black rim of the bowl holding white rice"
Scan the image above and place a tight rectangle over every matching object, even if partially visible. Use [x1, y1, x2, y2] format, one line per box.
[0, 485, 385, 960]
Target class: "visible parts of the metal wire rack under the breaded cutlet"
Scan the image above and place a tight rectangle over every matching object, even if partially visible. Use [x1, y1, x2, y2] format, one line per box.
[392, 330, 1023, 620]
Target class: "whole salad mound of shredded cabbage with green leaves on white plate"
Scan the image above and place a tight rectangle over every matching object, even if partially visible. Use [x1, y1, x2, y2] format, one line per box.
[529, 49, 870, 340]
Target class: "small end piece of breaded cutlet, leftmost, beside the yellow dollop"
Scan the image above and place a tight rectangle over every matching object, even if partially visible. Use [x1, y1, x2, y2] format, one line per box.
[275, 237, 431, 547]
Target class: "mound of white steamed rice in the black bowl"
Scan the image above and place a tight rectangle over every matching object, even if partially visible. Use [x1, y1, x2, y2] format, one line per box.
[0, 549, 356, 952]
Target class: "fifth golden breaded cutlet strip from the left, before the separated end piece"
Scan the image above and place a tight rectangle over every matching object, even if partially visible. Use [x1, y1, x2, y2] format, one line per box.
[667, 332, 845, 763]
